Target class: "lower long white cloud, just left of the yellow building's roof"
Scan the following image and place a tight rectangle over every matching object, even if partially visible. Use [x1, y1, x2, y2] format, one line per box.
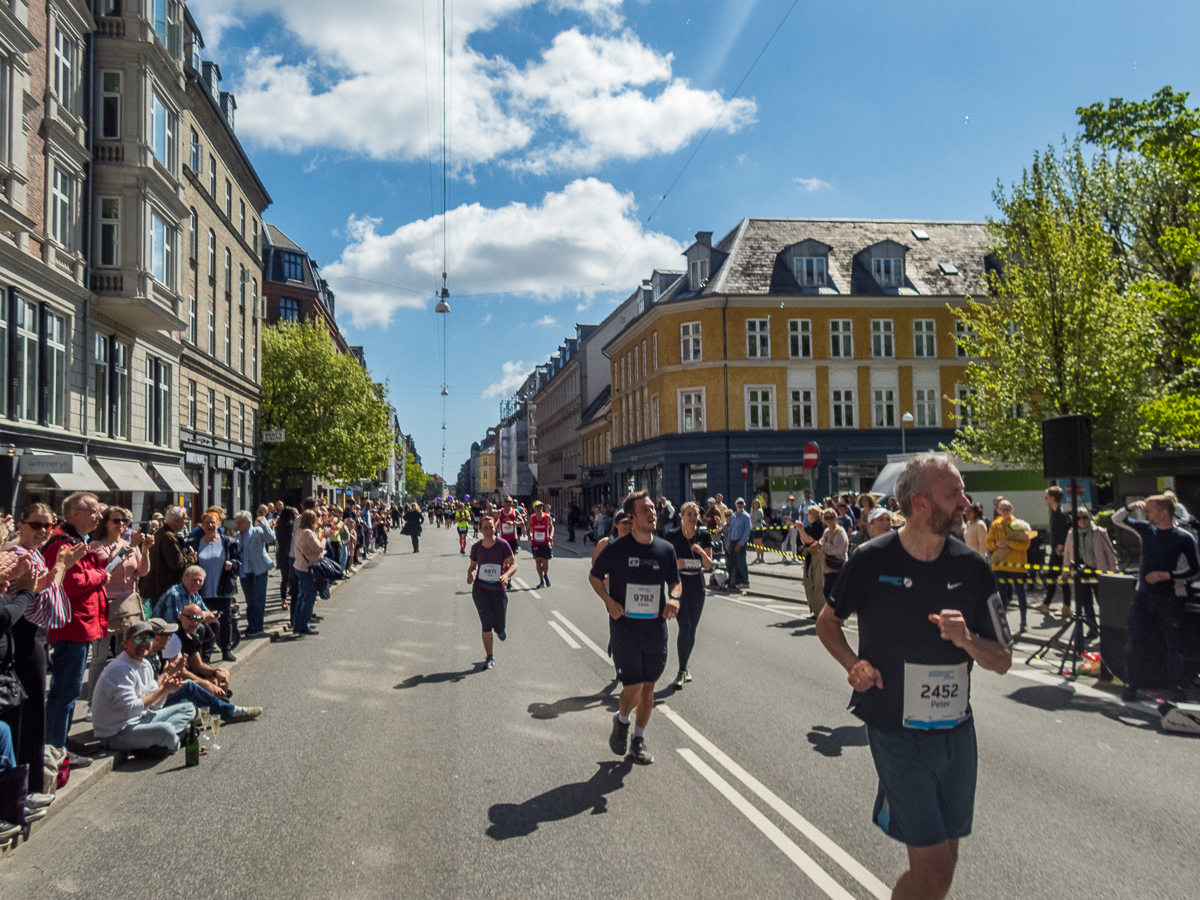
[323, 178, 684, 328]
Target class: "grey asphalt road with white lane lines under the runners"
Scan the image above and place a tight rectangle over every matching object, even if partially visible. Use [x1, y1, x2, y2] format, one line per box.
[0, 528, 1200, 900]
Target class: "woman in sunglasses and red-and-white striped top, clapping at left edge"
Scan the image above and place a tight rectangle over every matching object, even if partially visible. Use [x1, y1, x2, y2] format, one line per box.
[4, 503, 88, 793]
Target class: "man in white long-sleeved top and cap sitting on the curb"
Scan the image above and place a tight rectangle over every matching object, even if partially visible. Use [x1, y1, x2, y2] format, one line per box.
[91, 622, 196, 756]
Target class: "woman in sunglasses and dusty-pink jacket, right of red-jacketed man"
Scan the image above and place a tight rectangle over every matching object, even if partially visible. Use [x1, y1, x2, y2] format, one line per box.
[88, 506, 158, 703]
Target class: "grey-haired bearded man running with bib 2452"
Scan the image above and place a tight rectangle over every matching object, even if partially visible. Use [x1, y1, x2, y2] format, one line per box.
[817, 452, 1013, 899]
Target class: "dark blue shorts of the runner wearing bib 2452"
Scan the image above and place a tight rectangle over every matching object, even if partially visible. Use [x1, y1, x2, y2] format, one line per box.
[866, 719, 978, 847]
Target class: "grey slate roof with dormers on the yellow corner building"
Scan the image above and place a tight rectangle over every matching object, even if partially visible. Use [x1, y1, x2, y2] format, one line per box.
[705, 218, 990, 299]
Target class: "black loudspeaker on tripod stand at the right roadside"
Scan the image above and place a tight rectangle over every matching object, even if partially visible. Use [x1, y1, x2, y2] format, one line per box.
[1025, 415, 1092, 680]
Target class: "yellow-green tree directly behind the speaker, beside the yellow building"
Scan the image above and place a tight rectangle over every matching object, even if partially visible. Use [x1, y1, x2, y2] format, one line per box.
[950, 142, 1154, 480]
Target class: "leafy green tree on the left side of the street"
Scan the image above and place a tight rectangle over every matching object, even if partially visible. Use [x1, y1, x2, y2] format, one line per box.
[262, 322, 396, 494]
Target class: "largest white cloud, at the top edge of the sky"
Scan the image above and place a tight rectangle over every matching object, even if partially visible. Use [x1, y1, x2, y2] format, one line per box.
[198, 0, 756, 175]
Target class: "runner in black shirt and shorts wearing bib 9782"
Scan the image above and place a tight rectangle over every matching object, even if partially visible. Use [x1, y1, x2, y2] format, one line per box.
[588, 491, 682, 766]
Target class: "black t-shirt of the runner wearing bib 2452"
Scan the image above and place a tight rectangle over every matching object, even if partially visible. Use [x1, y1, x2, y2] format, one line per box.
[830, 532, 1007, 730]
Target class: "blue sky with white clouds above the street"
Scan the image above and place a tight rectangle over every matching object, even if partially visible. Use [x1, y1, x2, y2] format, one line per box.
[190, 0, 1200, 481]
